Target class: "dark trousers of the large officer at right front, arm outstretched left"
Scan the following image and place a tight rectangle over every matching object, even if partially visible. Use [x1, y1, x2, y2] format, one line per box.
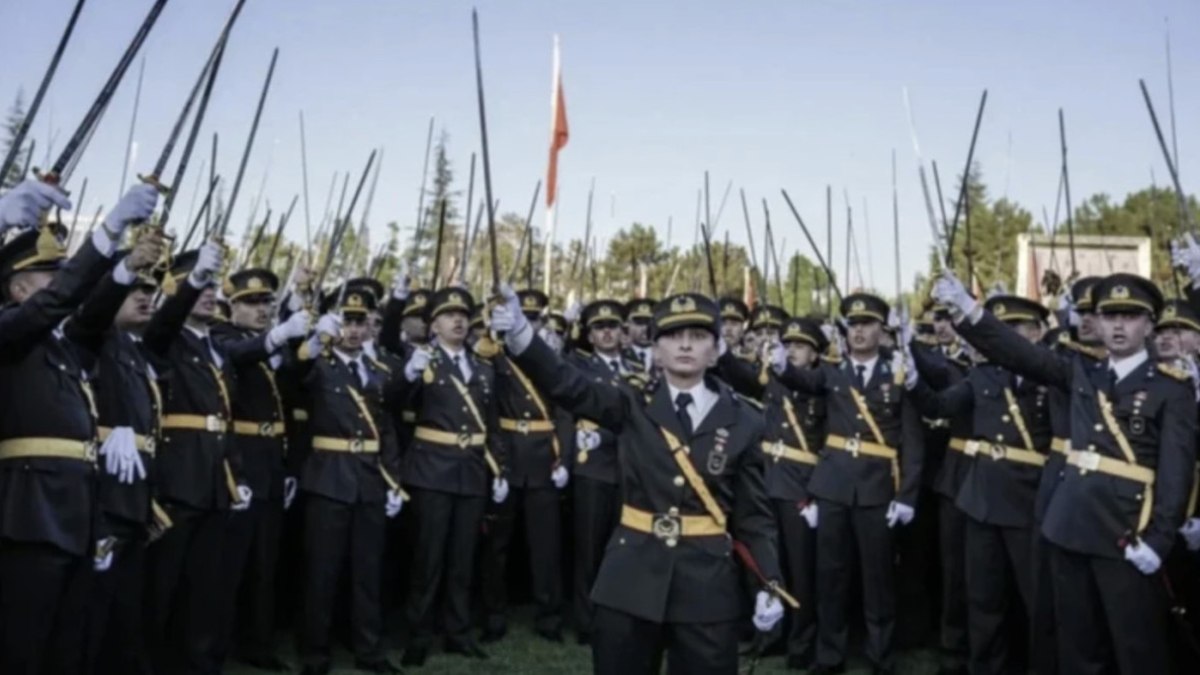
[1046, 543, 1172, 675]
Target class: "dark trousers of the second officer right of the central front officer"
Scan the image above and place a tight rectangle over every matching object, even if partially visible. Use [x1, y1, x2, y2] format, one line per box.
[817, 500, 896, 668]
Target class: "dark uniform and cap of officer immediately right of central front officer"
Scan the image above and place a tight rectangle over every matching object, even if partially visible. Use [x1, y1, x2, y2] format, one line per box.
[718, 318, 829, 669]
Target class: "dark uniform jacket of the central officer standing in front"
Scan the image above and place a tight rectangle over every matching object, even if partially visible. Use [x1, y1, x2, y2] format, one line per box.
[515, 339, 780, 623]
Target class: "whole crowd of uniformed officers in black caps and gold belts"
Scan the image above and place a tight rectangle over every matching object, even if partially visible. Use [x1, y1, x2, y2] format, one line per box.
[0, 181, 1200, 675]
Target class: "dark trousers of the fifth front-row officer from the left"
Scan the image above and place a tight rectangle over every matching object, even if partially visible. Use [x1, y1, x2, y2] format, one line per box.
[299, 494, 386, 667]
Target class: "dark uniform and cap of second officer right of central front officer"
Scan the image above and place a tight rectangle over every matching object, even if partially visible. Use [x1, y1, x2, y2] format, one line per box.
[781, 294, 923, 671]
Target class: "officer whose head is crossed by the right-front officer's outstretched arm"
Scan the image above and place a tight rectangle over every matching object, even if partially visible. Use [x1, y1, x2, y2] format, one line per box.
[914, 295, 1051, 674]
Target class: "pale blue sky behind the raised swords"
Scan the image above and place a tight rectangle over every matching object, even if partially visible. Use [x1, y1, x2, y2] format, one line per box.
[0, 0, 1200, 291]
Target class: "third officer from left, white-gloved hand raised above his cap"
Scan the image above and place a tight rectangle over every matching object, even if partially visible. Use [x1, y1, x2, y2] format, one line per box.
[143, 241, 253, 671]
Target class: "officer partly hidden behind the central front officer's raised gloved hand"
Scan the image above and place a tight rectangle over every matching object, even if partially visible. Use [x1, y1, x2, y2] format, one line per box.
[481, 284, 571, 643]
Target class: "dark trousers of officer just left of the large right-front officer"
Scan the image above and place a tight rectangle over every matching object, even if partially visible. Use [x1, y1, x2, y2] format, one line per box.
[966, 518, 1033, 675]
